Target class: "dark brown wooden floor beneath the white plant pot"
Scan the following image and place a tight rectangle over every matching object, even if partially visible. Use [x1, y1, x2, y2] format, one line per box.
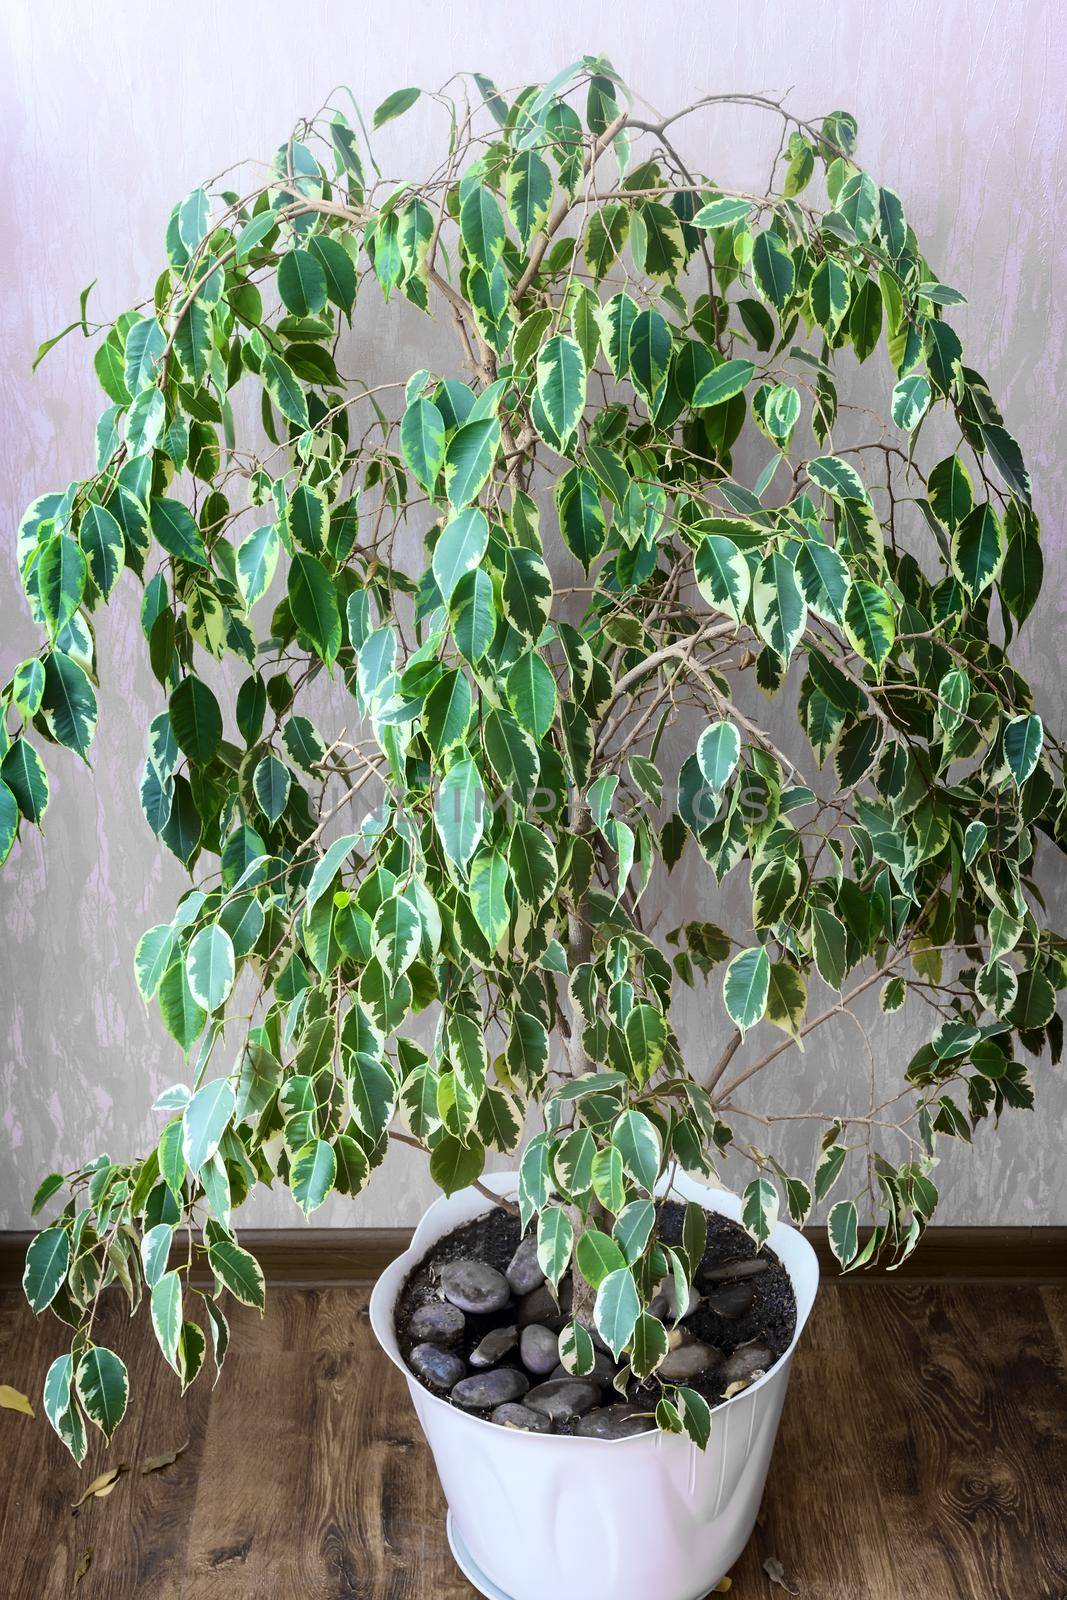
[0, 1280, 1067, 1600]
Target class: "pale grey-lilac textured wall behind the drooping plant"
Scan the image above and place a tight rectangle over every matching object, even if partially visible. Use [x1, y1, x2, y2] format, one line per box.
[0, 0, 1067, 1227]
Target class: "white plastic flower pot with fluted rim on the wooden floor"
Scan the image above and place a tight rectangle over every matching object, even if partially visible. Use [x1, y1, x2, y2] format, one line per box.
[371, 1173, 819, 1600]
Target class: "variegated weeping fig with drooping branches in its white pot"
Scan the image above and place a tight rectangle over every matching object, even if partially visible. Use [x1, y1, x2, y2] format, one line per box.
[0, 58, 1064, 1600]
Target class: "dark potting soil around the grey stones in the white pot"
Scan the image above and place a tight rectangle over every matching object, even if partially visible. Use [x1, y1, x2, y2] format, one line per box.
[394, 1200, 797, 1434]
